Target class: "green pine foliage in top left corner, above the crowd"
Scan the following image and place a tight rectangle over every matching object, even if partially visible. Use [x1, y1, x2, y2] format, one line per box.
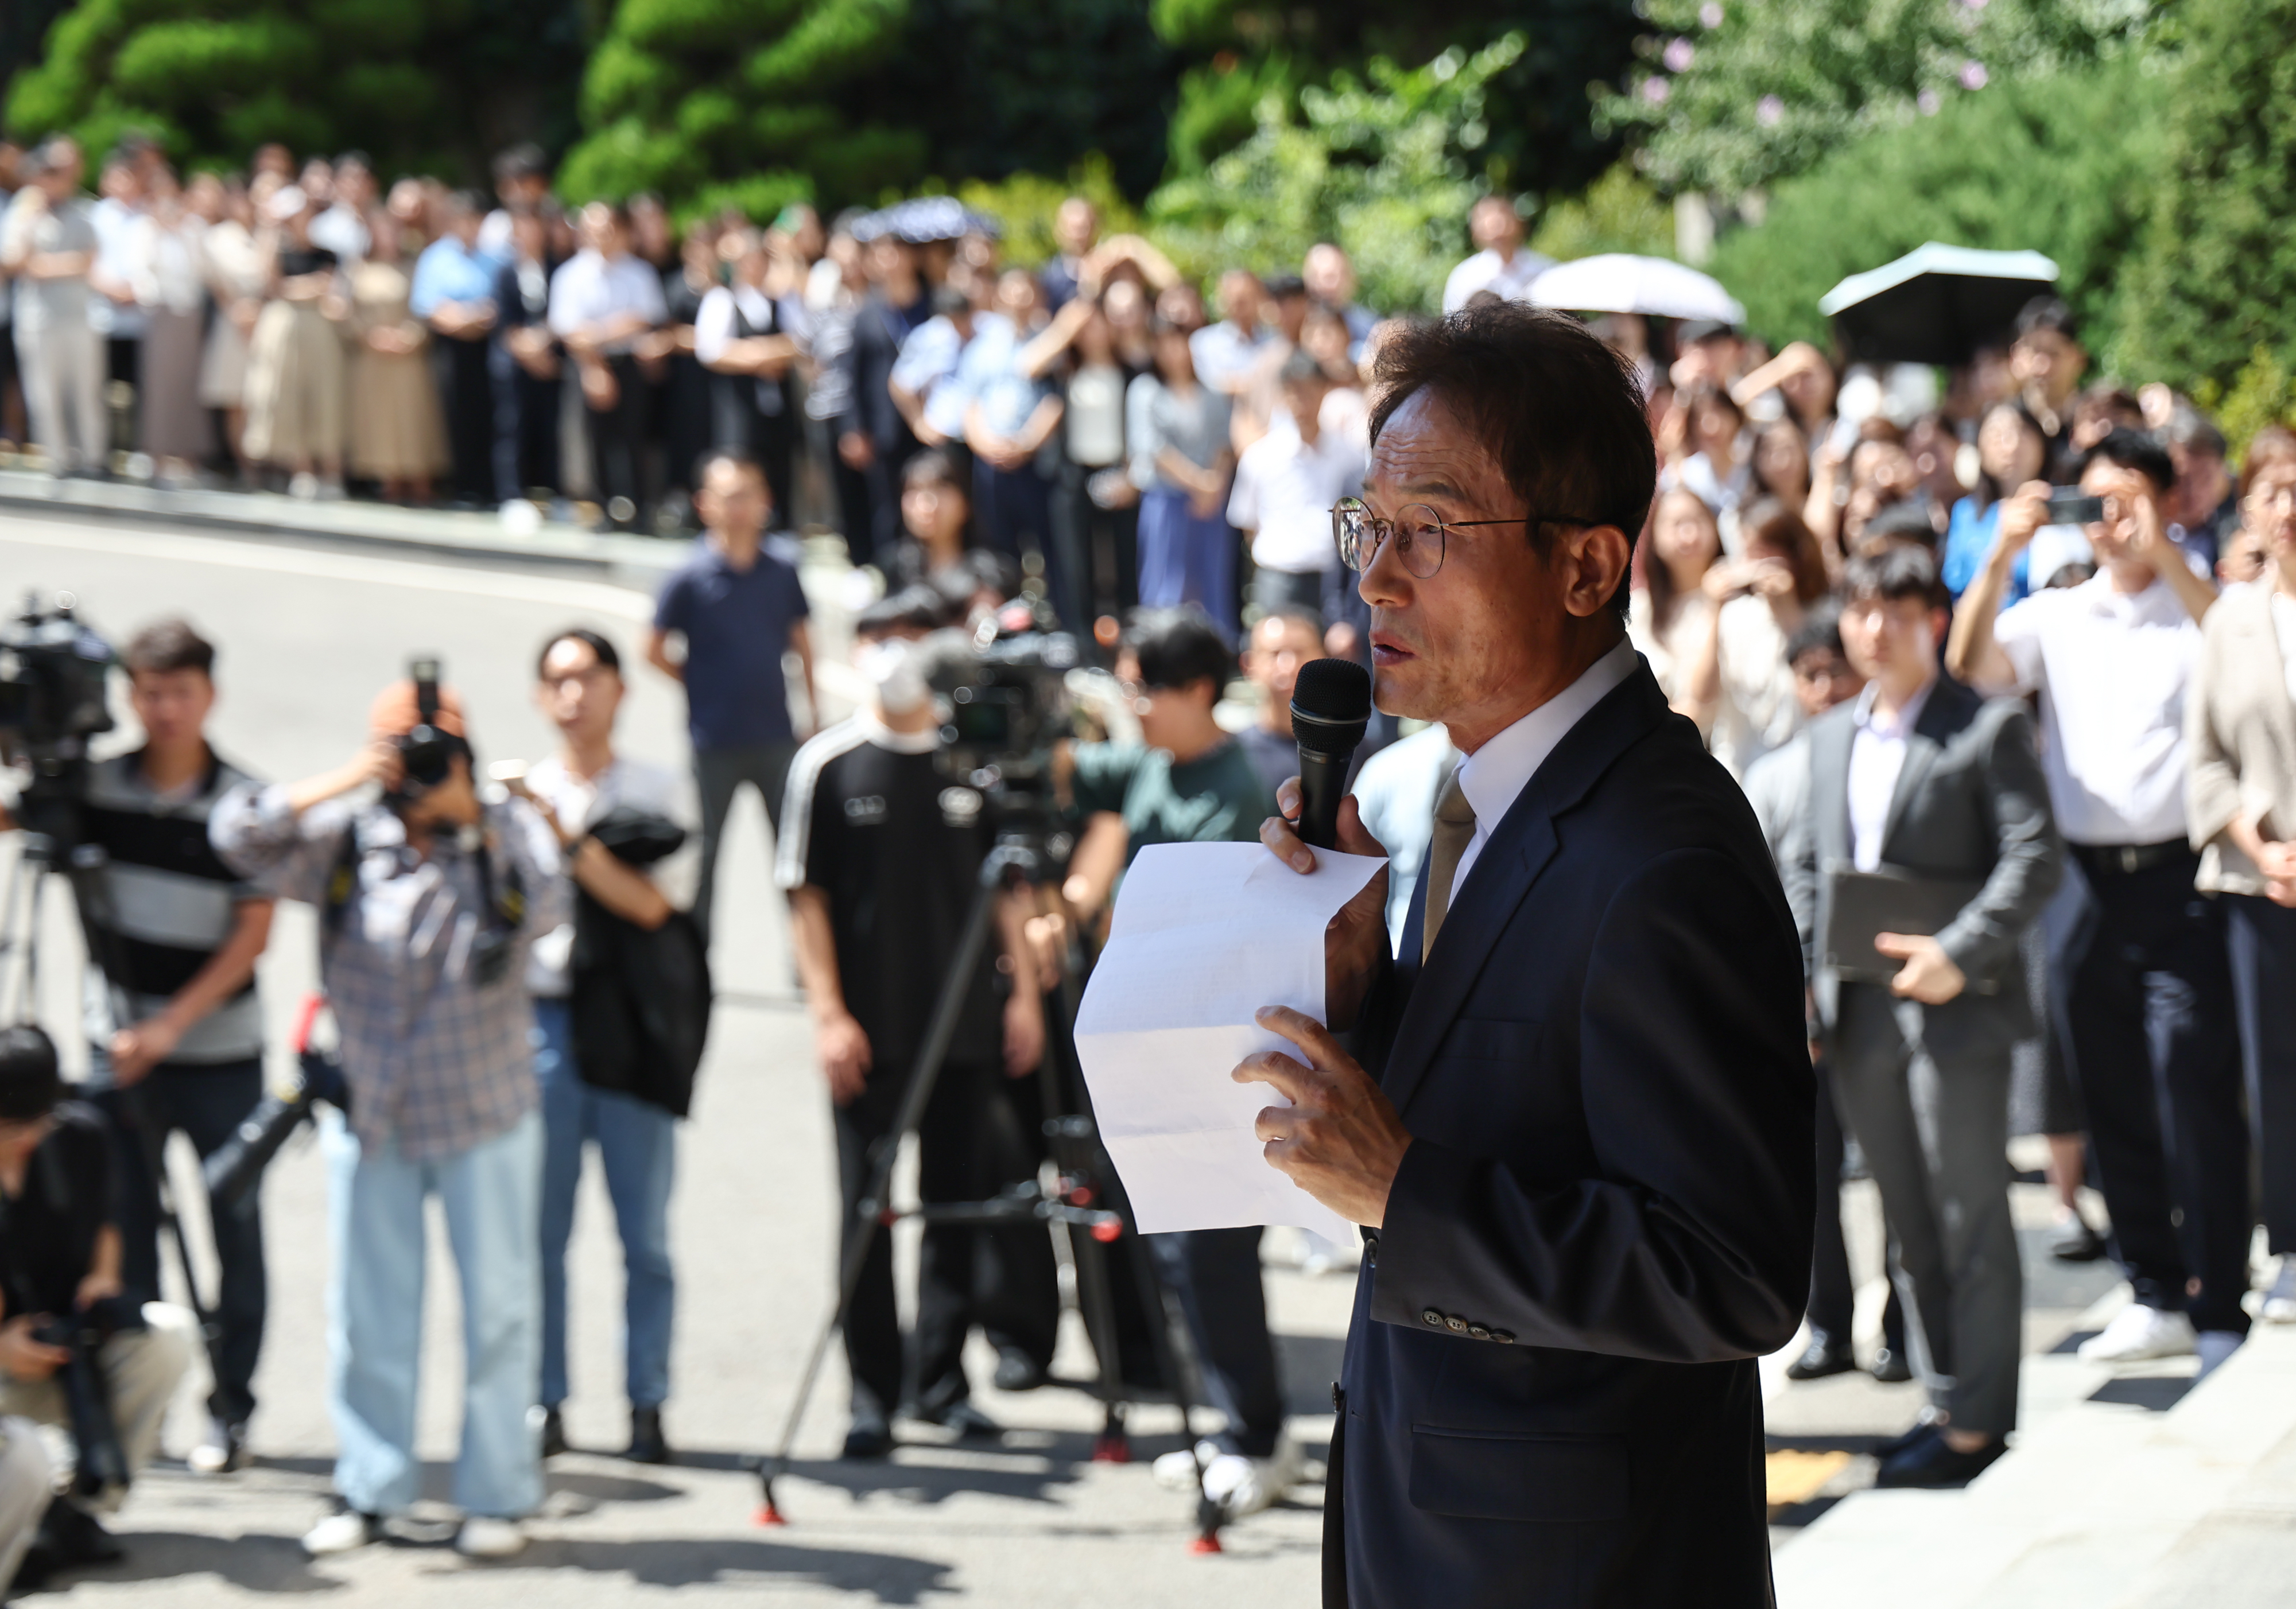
[7, 0, 581, 179]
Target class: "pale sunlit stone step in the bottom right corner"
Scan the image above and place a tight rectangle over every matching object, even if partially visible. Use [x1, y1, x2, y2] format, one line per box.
[1775, 1297, 2296, 1609]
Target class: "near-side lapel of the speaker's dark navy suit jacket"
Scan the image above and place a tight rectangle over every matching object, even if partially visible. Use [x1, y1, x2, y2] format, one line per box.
[1380, 663, 1667, 1111]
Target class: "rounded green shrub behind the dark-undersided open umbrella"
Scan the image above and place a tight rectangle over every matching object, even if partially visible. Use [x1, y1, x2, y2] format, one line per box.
[1708, 55, 2170, 347]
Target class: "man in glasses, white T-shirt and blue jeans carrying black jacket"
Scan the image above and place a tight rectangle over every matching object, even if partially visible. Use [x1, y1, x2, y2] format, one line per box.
[521, 627, 677, 1464]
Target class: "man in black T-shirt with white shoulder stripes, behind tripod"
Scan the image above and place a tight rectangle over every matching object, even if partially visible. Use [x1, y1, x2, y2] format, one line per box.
[774, 588, 1058, 1458]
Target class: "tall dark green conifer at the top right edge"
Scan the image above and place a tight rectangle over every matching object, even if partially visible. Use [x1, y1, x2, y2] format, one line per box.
[2122, 0, 2296, 386]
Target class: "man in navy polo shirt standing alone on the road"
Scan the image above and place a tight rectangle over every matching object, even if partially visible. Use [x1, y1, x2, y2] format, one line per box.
[645, 448, 815, 932]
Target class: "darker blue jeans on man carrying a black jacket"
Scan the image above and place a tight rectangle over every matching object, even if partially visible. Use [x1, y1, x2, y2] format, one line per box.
[535, 1001, 677, 1407]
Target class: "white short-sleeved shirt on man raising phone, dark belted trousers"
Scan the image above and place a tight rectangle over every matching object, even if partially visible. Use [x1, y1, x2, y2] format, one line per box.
[1979, 572, 2200, 845]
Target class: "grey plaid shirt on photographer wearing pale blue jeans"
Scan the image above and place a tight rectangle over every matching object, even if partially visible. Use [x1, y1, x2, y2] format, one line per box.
[209, 785, 572, 1161]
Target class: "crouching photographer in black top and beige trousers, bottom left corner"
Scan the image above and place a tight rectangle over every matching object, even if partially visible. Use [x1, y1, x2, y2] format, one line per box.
[0, 1026, 200, 1586]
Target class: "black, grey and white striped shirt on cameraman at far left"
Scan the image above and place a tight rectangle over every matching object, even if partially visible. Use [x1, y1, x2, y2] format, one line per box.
[80, 751, 264, 1067]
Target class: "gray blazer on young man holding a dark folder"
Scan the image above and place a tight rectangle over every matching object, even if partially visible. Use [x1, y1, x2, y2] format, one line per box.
[1784, 677, 2064, 1060]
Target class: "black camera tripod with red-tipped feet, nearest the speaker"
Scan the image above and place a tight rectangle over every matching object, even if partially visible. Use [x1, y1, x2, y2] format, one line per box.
[748, 808, 1226, 1554]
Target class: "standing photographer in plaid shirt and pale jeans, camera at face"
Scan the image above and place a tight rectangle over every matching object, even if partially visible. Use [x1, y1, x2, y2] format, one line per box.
[209, 666, 567, 1559]
